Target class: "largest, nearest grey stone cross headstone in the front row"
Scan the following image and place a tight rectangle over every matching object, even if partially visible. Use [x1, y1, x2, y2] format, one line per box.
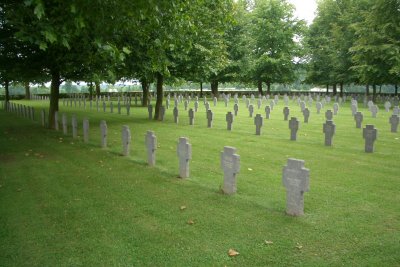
[282, 159, 310, 216]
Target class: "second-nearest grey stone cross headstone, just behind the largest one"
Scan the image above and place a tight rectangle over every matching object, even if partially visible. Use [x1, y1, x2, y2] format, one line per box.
[221, 146, 240, 194]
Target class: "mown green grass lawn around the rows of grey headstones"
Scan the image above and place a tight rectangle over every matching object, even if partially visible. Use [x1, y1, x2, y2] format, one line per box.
[0, 99, 400, 266]
